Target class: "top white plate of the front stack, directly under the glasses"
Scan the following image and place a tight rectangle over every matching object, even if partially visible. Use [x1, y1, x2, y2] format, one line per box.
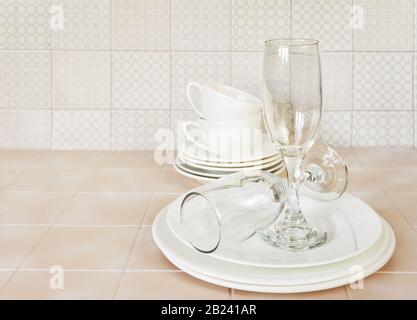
[168, 194, 382, 268]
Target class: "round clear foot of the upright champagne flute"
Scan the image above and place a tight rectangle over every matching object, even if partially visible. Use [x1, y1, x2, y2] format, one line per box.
[258, 225, 327, 251]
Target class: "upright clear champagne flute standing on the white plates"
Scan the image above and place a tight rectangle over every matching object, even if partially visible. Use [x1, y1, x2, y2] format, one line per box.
[263, 39, 327, 250]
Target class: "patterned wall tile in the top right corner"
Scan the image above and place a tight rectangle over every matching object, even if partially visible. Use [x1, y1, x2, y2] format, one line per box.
[354, 0, 413, 51]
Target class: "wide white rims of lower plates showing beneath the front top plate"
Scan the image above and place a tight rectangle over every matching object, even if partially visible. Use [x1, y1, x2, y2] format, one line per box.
[152, 208, 395, 293]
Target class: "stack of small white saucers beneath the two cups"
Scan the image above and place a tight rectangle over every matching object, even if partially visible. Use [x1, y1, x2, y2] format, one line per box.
[174, 135, 284, 183]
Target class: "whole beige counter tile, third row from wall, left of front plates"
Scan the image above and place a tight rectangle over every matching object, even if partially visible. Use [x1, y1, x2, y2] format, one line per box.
[56, 193, 151, 226]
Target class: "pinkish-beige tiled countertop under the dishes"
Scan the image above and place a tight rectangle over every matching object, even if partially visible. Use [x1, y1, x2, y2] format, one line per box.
[0, 149, 417, 299]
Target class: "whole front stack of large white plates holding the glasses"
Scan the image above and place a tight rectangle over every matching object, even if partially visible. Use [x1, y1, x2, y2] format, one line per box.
[153, 190, 395, 293]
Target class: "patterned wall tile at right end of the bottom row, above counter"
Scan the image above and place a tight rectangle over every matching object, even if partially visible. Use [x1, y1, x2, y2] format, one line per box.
[353, 111, 413, 147]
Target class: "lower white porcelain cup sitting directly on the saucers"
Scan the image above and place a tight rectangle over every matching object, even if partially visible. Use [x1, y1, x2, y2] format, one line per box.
[183, 114, 262, 159]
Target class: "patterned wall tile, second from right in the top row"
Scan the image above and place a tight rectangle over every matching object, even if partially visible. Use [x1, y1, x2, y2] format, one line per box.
[293, 0, 352, 50]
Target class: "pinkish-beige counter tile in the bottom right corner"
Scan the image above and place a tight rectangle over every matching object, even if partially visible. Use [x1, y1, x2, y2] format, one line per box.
[349, 273, 417, 300]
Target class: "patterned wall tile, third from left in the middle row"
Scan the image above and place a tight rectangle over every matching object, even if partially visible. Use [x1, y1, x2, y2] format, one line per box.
[113, 52, 171, 110]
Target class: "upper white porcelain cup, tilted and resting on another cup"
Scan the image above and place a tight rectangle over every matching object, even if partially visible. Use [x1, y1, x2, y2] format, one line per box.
[187, 82, 262, 120]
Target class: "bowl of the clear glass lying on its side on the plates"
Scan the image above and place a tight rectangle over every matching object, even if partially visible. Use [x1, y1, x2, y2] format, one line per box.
[180, 170, 287, 253]
